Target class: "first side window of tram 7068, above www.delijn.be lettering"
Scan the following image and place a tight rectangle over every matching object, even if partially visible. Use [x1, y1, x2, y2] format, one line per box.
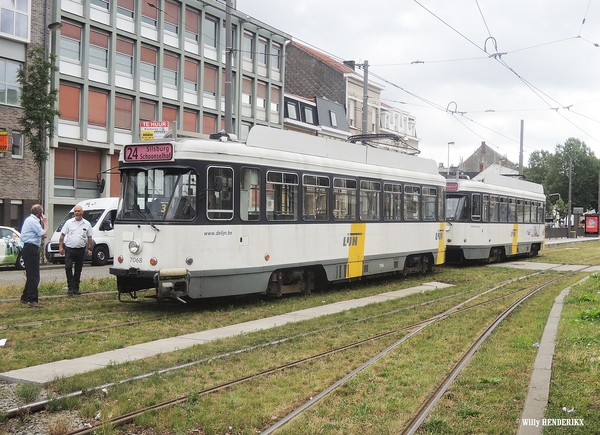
[206, 166, 233, 220]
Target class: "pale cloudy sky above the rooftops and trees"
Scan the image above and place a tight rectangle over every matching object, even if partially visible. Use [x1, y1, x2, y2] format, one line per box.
[237, 0, 600, 166]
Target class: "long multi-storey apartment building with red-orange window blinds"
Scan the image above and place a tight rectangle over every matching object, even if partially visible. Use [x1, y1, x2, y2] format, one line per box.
[45, 0, 289, 230]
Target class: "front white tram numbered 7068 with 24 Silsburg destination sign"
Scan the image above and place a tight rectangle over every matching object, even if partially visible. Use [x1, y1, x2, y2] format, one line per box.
[110, 126, 446, 300]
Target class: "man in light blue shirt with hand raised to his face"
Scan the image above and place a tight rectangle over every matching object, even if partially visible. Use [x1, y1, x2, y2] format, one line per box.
[21, 204, 48, 308]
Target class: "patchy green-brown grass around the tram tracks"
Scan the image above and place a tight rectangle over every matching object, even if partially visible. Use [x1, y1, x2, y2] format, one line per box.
[0, 243, 600, 434]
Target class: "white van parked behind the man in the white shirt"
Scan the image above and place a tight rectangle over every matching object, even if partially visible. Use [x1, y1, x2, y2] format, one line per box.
[46, 198, 119, 266]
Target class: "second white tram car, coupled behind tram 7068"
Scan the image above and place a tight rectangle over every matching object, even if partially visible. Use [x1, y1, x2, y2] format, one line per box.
[446, 174, 546, 263]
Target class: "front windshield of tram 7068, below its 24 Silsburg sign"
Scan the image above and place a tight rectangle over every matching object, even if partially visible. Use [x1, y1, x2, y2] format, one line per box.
[117, 168, 198, 221]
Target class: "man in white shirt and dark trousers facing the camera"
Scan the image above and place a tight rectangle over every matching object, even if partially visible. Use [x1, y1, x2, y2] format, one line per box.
[58, 205, 94, 295]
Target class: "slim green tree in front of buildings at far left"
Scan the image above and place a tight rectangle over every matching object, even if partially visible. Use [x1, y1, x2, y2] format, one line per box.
[17, 46, 60, 192]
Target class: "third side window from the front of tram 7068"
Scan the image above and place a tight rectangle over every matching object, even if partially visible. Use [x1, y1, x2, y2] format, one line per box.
[266, 171, 298, 221]
